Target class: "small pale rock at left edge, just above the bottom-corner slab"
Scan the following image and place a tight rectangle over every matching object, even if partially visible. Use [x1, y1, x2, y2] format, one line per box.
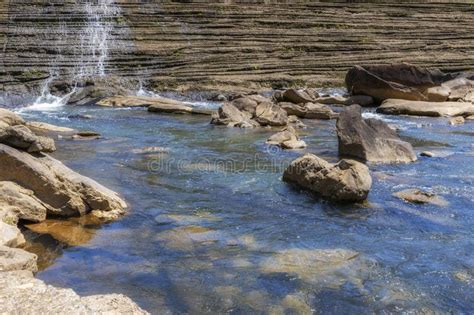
[0, 245, 38, 272]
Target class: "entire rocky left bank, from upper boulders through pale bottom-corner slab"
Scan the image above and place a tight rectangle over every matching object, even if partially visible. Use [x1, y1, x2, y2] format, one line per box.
[0, 109, 146, 314]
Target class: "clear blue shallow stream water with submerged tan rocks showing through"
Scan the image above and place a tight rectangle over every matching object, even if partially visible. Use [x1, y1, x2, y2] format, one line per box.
[13, 104, 474, 314]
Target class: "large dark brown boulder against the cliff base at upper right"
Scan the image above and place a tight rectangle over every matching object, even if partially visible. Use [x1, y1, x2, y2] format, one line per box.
[346, 64, 452, 101]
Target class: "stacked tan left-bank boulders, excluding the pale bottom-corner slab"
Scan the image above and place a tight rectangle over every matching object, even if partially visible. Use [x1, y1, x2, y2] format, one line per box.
[0, 109, 127, 273]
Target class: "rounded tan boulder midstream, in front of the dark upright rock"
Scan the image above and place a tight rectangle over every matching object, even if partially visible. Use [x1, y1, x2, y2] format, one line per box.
[283, 154, 372, 202]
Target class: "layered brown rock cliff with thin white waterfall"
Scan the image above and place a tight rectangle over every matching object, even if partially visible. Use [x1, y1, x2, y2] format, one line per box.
[0, 0, 474, 94]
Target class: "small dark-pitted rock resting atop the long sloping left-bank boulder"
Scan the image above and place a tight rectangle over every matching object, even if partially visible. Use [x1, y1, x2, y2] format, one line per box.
[0, 125, 56, 152]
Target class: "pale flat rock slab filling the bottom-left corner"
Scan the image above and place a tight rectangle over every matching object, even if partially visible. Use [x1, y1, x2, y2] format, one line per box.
[0, 271, 148, 314]
